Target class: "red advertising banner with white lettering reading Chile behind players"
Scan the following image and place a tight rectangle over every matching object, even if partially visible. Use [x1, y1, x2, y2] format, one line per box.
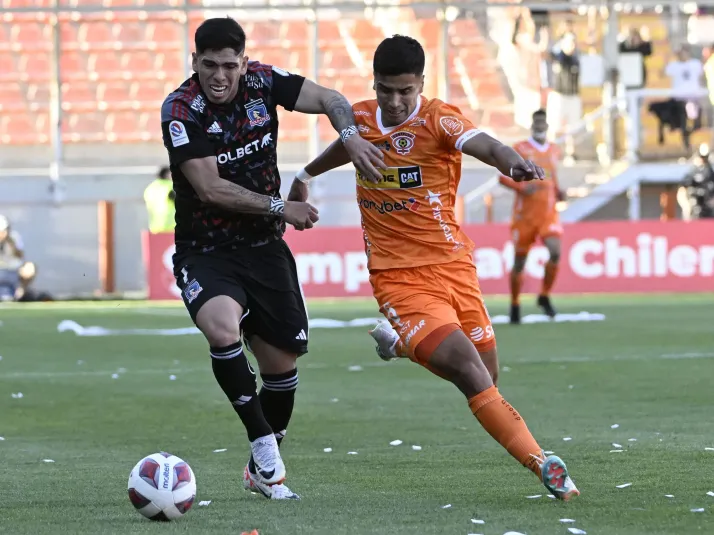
[144, 220, 714, 299]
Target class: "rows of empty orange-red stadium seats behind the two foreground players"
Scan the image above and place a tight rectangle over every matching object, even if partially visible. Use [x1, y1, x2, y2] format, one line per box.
[0, 5, 512, 145]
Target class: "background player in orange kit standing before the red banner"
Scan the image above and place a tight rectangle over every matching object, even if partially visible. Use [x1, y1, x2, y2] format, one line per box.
[499, 110, 563, 323]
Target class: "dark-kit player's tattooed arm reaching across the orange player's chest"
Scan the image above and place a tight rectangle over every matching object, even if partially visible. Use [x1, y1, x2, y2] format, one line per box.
[295, 80, 386, 181]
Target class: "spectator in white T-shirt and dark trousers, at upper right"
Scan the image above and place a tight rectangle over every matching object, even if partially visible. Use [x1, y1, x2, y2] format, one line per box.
[660, 45, 704, 150]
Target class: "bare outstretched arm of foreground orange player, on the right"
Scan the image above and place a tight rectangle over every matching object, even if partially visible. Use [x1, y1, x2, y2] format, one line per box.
[461, 132, 545, 182]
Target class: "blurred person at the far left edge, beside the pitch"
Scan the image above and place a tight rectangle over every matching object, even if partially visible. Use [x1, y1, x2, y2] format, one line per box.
[0, 215, 36, 301]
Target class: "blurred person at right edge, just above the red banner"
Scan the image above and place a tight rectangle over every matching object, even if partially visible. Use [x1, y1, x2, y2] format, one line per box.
[677, 145, 714, 221]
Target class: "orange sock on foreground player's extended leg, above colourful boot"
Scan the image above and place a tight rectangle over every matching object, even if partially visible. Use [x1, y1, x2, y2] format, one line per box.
[469, 386, 543, 478]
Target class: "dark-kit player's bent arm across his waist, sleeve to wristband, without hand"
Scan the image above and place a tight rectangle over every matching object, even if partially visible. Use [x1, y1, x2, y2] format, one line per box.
[181, 156, 274, 215]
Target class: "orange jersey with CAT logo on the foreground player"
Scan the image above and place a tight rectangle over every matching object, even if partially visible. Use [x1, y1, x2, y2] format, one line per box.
[352, 97, 480, 271]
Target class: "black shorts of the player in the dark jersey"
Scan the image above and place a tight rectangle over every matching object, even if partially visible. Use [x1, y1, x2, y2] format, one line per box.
[174, 240, 308, 355]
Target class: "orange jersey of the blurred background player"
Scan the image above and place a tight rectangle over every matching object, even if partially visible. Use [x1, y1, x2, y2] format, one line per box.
[501, 139, 560, 222]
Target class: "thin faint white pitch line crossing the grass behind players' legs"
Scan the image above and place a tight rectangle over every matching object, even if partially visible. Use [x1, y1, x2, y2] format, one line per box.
[0, 352, 714, 380]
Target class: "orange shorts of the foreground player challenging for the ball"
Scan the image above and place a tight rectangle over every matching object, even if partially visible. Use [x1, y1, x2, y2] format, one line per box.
[369, 254, 496, 364]
